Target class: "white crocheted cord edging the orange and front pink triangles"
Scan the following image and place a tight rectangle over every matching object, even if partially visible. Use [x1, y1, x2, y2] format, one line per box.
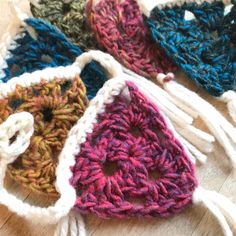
[0, 51, 196, 224]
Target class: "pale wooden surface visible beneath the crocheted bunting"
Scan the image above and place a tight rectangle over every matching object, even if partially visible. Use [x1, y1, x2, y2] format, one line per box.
[0, 0, 236, 236]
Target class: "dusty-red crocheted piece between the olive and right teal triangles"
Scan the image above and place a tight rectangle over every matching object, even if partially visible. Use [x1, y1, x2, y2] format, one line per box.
[87, 0, 175, 79]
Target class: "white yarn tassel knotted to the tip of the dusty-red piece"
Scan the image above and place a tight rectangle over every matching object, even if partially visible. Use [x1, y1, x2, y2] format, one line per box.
[157, 73, 236, 167]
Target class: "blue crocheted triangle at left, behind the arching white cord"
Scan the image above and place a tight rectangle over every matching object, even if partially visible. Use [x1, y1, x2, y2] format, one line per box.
[0, 18, 106, 99]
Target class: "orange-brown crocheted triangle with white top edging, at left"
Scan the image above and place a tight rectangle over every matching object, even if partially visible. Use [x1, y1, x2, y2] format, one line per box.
[0, 71, 87, 195]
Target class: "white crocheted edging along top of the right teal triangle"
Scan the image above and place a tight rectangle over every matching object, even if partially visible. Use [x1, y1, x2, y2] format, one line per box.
[136, 0, 231, 16]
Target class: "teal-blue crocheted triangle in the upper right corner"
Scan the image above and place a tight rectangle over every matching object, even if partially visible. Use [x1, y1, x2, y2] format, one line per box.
[145, 0, 236, 97]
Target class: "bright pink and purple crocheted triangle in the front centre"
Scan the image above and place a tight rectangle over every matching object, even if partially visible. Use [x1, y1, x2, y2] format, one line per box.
[71, 82, 197, 218]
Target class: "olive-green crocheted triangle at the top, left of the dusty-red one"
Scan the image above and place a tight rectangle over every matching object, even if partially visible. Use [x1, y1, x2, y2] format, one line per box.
[30, 0, 98, 50]
